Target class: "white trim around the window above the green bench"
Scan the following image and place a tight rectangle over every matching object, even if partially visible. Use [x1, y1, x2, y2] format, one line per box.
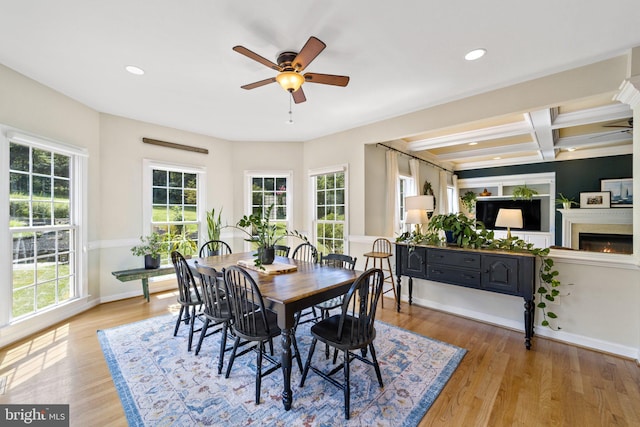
[141, 159, 207, 243]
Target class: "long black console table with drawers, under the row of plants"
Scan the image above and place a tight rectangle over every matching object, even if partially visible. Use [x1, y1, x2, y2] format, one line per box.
[396, 243, 535, 350]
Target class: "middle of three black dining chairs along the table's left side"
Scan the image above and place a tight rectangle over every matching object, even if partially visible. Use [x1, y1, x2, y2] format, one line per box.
[195, 261, 232, 374]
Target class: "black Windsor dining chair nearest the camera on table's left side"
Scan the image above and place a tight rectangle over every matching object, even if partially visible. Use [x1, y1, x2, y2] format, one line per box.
[224, 265, 302, 405]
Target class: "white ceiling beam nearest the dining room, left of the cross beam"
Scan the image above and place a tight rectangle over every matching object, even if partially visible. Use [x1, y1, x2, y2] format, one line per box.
[407, 120, 531, 151]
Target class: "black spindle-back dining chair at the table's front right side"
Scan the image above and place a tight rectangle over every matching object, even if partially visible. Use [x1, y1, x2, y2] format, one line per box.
[300, 268, 384, 420]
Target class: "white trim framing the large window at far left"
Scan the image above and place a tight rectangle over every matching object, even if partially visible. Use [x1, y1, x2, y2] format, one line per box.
[0, 125, 89, 330]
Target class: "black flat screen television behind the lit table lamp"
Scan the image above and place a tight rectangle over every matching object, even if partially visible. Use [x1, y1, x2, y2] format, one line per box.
[476, 199, 542, 231]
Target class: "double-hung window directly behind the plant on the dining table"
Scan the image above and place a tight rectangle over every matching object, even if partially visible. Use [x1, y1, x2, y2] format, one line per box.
[245, 171, 292, 249]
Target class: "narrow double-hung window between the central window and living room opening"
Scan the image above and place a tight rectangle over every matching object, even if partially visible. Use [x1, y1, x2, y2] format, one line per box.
[310, 166, 348, 254]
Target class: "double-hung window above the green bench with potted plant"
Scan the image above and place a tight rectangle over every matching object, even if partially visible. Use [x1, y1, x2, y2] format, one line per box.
[144, 160, 204, 264]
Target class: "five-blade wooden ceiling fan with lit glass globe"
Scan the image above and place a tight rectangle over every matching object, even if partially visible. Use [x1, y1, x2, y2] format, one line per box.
[233, 36, 349, 104]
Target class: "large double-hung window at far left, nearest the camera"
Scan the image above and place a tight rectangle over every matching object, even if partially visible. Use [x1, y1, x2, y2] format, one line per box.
[0, 132, 87, 324]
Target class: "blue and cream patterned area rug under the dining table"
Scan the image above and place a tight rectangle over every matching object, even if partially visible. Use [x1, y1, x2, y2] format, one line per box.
[98, 315, 466, 427]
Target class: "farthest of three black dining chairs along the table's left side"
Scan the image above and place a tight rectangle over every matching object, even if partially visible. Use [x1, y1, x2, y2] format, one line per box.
[171, 251, 203, 351]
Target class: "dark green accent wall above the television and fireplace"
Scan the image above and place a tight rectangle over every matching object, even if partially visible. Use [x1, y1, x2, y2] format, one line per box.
[456, 154, 633, 245]
